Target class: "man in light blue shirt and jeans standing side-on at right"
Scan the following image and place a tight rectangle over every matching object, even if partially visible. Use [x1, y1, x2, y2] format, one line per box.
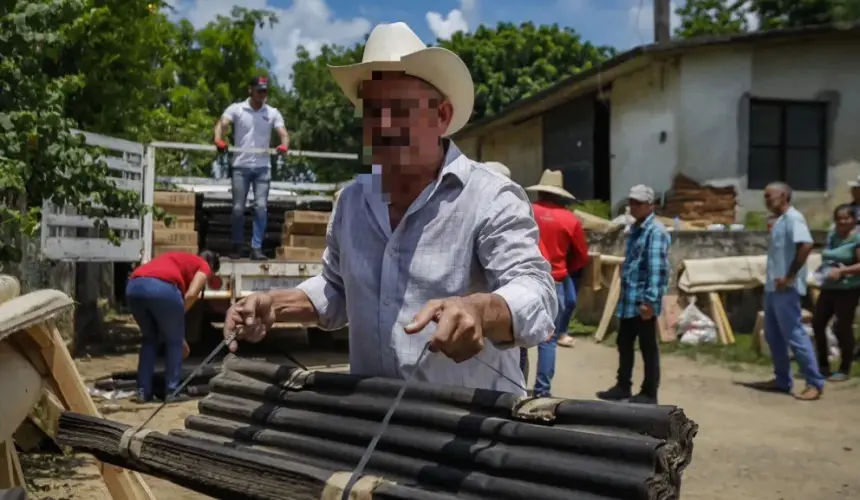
[758, 182, 824, 401]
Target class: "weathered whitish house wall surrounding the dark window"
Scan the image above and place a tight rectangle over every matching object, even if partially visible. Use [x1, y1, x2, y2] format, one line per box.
[611, 37, 860, 221]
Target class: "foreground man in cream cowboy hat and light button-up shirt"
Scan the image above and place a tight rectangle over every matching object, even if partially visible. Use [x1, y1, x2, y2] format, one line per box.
[224, 23, 557, 395]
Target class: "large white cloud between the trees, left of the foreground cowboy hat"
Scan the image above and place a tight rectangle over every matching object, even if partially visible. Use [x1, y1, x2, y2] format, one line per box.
[167, 0, 371, 87]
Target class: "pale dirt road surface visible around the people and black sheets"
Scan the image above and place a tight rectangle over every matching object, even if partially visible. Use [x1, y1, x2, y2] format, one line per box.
[20, 341, 860, 500]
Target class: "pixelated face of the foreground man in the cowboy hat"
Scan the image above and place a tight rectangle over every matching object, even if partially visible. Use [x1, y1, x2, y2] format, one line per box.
[359, 72, 454, 172]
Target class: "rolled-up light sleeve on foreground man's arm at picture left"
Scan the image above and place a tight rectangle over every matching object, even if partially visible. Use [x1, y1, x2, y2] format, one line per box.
[296, 189, 348, 330]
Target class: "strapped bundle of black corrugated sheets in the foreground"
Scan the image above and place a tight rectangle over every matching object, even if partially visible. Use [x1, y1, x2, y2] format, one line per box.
[59, 356, 697, 500]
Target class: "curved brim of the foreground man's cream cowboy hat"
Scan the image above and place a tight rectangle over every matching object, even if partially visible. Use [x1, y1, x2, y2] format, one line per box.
[329, 47, 475, 137]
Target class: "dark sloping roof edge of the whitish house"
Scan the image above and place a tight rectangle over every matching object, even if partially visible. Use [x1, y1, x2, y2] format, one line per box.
[454, 23, 860, 139]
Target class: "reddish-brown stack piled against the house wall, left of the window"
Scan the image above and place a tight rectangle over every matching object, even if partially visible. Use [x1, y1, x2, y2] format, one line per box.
[661, 175, 737, 224]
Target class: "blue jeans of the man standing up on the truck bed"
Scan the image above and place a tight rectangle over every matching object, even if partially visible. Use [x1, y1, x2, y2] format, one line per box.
[231, 166, 272, 249]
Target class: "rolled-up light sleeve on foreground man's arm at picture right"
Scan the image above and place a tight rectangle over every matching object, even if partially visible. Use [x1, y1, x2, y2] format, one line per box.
[476, 183, 558, 347]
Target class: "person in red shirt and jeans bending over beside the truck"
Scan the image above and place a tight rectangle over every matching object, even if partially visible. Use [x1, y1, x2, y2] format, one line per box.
[125, 250, 220, 403]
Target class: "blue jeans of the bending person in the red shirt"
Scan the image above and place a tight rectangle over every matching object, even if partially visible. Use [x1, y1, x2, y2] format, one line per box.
[125, 278, 185, 399]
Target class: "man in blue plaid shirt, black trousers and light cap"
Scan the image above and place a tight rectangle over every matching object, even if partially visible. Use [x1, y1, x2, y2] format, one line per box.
[597, 184, 670, 404]
